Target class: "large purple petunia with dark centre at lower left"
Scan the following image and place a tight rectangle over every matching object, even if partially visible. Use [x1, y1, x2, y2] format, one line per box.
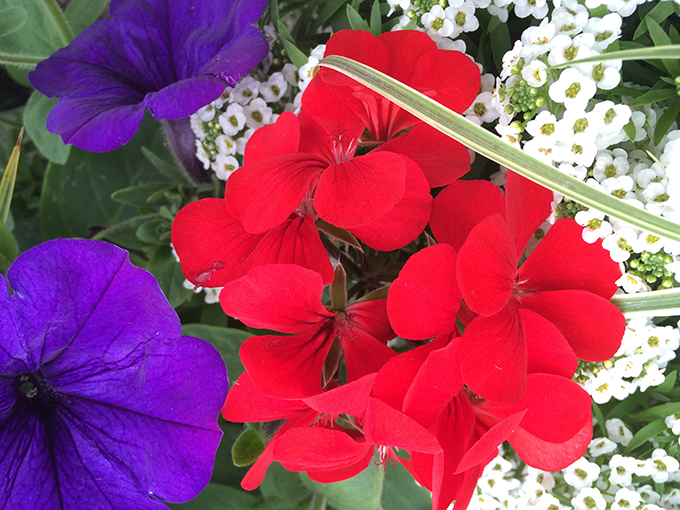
[0, 239, 228, 510]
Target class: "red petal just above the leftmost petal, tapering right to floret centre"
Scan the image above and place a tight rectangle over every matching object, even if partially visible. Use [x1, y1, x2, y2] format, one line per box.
[225, 153, 328, 234]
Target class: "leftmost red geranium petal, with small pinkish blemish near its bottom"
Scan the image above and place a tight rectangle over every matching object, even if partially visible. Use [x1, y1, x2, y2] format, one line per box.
[172, 198, 262, 287]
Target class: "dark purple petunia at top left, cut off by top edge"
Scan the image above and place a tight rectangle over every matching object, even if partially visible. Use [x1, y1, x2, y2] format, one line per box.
[29, 0, 269, 152]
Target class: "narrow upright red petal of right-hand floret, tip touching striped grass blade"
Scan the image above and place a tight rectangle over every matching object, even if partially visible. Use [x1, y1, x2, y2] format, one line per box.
[505, 171, 552, 263]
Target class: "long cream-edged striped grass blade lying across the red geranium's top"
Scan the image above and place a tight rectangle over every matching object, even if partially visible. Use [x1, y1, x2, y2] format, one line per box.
[321, 54, 680, 241]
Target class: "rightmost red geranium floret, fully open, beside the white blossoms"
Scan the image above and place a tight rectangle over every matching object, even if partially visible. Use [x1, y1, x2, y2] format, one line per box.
[387, 172, 625, 402]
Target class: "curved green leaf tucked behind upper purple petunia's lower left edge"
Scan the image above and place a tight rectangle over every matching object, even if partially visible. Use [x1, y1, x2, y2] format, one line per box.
[24, 90, 71, 165]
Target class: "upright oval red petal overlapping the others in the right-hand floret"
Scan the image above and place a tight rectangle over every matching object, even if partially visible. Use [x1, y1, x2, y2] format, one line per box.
[456, 213, 517, 317]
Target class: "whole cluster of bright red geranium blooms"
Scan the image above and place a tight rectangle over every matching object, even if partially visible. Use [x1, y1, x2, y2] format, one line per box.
[173, 31, 625, 510]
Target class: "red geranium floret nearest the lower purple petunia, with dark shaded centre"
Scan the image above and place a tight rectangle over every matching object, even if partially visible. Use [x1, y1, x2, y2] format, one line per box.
[220, 264, 395, 399]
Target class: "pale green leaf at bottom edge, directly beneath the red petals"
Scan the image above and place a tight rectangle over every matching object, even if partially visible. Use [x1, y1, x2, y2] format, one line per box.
[300, 462, 385, 510]
